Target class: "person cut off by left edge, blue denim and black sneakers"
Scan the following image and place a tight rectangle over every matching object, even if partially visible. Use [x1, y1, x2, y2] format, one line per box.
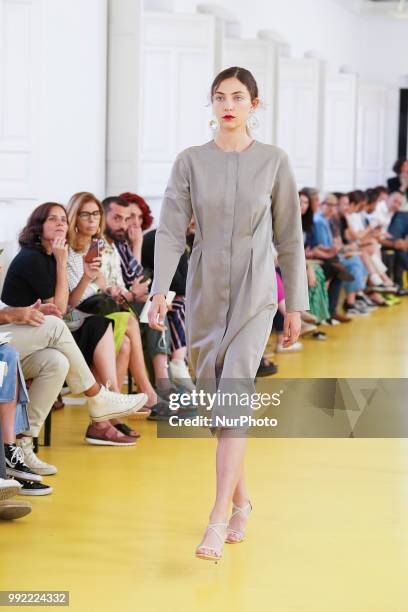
[0, 344, 52, 495]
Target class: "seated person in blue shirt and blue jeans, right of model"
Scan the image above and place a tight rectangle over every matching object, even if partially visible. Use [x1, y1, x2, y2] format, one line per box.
[313, 194, 369, 316]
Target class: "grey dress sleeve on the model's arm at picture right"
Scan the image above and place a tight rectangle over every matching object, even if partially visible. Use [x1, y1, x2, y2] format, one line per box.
[272, 154, 309, 312]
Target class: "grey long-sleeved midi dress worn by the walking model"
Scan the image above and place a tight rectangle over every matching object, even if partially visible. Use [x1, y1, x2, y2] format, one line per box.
[150, 140, 309, 430]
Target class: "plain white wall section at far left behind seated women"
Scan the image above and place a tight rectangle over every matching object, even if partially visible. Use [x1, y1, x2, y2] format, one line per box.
[0, 0, 107, 256]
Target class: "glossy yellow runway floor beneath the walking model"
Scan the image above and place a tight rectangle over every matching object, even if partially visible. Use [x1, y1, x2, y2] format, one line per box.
[0, 298, 408, 612]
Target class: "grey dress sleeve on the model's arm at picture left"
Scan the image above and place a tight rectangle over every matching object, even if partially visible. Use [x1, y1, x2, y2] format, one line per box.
[150, 155, 193, 296]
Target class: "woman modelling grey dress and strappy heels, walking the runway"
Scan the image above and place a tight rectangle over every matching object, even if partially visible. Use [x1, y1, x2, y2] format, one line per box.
[149, 67, 309, 561]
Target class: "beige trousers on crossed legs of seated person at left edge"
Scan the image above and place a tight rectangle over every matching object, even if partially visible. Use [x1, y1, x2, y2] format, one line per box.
[0, 316, 95, 437]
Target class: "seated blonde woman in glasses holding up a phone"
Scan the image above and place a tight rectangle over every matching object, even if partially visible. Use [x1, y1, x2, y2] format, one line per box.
[68, 192, 174, 417]
